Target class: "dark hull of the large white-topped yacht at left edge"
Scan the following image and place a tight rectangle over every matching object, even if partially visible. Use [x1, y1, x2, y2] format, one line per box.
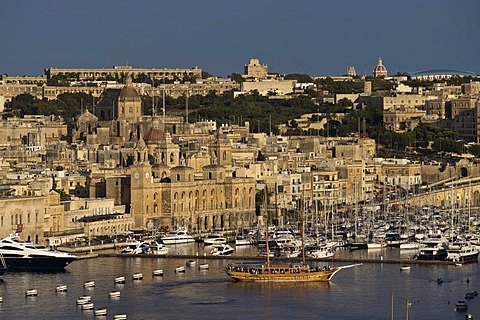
[4, 256, 75, 272]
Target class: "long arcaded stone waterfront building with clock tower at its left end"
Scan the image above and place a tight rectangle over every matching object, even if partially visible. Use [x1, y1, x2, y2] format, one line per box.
[130, 139, 255, 232]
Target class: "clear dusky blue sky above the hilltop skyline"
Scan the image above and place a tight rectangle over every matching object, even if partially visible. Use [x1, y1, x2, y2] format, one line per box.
[0, 0, 480, 76]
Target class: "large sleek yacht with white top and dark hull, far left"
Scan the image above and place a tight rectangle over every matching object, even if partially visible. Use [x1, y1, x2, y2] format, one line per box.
[0, 233, 76, 271]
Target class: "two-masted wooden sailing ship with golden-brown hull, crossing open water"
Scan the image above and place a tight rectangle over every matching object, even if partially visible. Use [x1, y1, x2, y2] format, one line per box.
[225, 190, 355, 282]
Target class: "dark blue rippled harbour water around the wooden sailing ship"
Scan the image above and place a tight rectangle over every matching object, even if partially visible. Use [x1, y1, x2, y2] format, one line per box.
[0, 245, 480, 320]
